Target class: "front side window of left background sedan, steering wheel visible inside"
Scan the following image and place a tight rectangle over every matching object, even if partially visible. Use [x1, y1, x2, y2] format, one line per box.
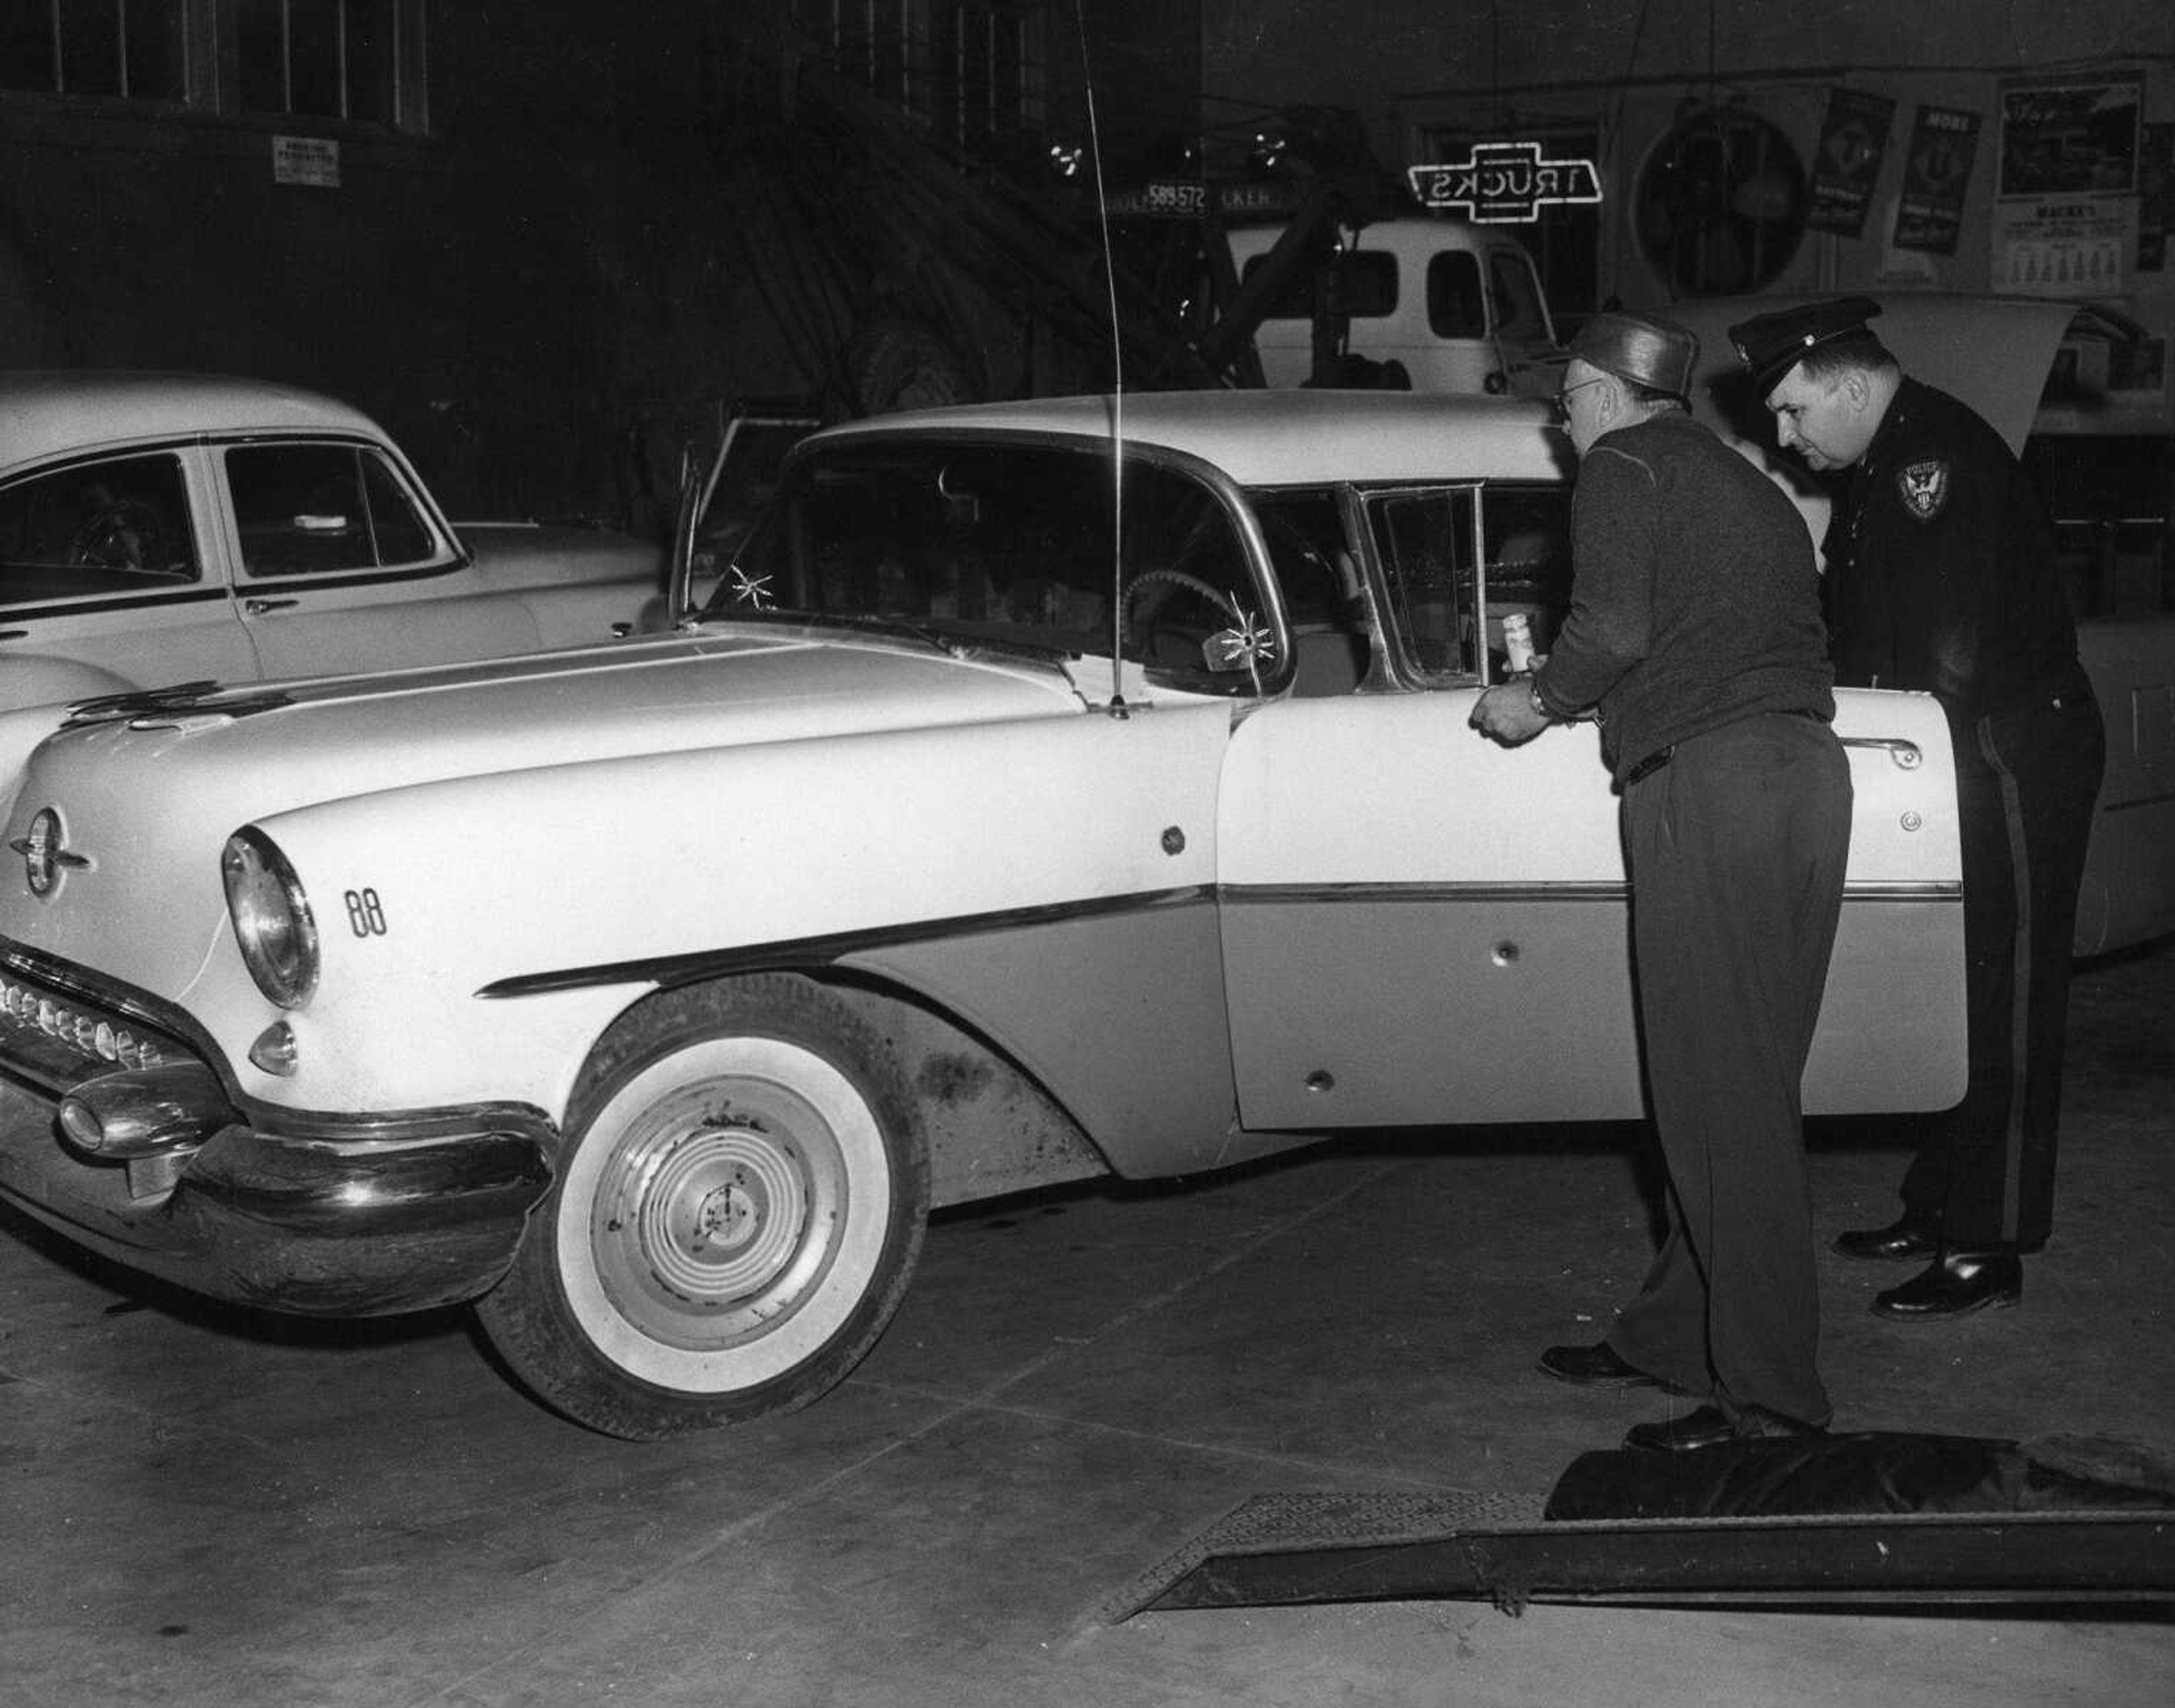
[0, 452, 202, 605]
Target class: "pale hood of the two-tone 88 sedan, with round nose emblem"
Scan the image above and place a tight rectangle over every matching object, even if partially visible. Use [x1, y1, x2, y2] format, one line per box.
[0, 629, 1085, 997]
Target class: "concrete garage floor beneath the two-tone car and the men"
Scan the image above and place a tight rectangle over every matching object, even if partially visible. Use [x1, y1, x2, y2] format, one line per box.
[12, 944, 2175, 1708]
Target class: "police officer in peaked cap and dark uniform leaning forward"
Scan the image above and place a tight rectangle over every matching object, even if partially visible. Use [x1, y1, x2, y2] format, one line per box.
[1729, 296, 2105, 1321]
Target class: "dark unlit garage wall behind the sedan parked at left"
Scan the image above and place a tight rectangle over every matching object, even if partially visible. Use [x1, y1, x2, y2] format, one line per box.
[0, 0, 1201, 524]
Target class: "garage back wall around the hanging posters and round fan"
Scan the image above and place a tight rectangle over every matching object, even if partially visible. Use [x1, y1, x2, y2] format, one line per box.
[1203, 0, 2175, 350]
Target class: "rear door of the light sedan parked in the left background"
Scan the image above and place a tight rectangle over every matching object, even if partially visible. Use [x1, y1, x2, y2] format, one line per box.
[218, 439, 541, 677]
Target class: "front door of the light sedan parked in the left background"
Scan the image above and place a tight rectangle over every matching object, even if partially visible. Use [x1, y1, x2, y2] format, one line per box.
[0, 446, 259, 707]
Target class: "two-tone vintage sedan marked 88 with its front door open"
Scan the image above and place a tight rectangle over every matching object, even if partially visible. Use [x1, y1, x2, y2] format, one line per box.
[0, 392, 1964, 1436]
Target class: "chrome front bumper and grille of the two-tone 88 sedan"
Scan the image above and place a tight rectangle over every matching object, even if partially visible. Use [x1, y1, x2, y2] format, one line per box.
[0, 944, 557, 1316]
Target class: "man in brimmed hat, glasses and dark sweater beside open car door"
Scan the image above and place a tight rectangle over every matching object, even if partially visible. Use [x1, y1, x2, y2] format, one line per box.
[1473, 313, 1851, 1449]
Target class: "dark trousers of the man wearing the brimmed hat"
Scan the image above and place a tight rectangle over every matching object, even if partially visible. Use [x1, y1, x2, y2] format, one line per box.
[1610, 714, 1851, 1423]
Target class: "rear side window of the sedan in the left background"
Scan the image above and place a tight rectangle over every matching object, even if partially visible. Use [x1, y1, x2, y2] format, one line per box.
[226, 444, 435, 577]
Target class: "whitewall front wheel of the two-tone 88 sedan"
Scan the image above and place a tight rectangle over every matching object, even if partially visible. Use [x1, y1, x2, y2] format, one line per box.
[476, 975, 929, 1440]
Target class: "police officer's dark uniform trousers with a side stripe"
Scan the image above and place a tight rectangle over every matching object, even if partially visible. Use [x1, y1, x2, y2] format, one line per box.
[1903, 672, 2108, 1251]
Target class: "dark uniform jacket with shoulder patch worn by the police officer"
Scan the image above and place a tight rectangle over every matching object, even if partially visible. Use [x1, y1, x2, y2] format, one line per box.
[1825, 379, 2077, 723]
